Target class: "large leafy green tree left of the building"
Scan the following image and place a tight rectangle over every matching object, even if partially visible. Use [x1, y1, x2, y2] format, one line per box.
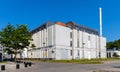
[0, 24, 34, 60]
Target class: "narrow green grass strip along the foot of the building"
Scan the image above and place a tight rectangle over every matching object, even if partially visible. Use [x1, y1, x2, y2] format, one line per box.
[19, 58, 120, 64]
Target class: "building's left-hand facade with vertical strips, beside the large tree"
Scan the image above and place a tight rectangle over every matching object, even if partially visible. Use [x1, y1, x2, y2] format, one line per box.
[28, 25, 55, 59]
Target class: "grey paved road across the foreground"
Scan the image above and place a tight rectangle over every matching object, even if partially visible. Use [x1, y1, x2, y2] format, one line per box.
[0, 61, 120, 72]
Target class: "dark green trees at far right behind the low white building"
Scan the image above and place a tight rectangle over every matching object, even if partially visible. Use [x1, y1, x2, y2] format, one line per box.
[107, 39, 120, 49]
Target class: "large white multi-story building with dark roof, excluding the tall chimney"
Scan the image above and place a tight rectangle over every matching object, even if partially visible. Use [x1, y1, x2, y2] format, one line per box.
[23, 22, 106, 60]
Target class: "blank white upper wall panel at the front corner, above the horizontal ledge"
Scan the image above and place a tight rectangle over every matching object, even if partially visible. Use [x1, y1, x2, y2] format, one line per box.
[55, 24, 70, 46]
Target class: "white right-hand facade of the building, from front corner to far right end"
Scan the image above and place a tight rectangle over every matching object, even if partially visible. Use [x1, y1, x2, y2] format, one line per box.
[55, 25, 106, 59]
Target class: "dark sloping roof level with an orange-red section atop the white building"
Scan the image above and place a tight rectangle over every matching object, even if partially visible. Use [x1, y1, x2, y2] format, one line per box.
[31, 21, 98, 35]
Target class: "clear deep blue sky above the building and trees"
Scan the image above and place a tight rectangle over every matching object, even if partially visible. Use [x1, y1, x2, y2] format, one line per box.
[0, 0, 120, 41]
